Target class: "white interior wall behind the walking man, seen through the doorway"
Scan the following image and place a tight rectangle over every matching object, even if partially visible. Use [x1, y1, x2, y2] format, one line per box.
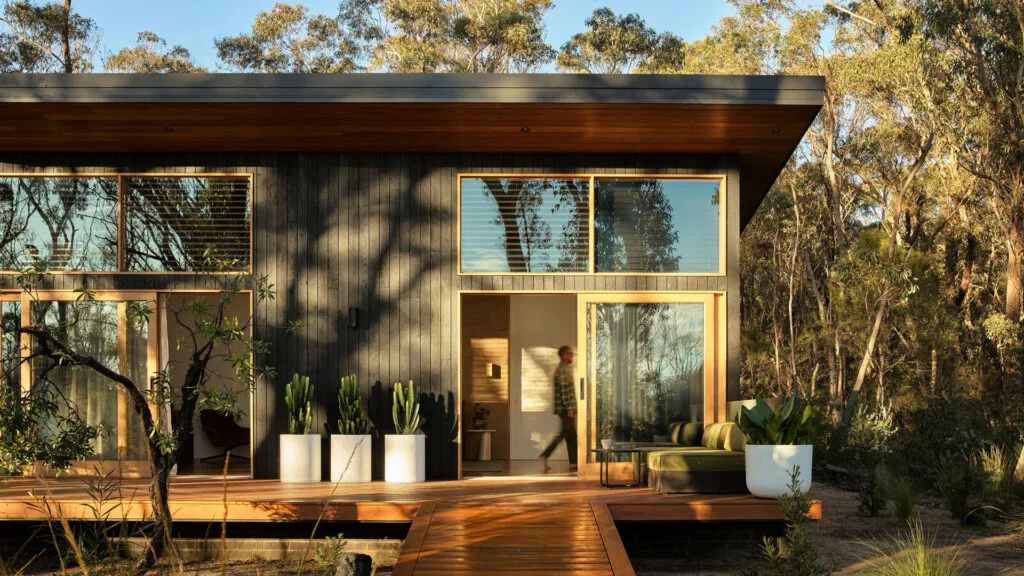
[509, 294, 577, 460]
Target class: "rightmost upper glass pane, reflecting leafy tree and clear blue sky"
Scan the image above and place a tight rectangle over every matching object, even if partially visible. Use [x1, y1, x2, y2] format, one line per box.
[594, 178, 722, 274]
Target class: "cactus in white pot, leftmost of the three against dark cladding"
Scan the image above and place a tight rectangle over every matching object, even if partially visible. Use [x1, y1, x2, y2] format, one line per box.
[280, 374, 321, 483]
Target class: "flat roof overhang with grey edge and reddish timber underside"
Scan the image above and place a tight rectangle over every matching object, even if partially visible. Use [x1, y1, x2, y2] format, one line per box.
[0, 74, 824, 225]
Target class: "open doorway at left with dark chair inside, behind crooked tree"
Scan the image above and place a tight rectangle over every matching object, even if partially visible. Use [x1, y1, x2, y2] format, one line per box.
[163, 292, 252, 477]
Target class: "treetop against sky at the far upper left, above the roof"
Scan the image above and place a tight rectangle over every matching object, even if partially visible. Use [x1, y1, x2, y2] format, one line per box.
[0, 0, 99, 74]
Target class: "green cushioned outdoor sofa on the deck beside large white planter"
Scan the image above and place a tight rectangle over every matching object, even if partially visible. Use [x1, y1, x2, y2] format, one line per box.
[646, 422, 746, 493]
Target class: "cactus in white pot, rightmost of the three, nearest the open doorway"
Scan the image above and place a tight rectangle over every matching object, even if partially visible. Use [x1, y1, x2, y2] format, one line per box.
[384, 380, 427, 482]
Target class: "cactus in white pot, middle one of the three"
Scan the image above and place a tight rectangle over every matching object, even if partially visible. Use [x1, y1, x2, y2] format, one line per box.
[325, 374, 373, 482]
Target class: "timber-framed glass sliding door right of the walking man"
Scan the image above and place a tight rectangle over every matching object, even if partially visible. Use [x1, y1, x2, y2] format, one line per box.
[577, 292, 725, 476]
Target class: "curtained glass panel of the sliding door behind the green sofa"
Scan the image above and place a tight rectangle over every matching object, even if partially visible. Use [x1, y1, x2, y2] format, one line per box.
[591, 303, 703, 442]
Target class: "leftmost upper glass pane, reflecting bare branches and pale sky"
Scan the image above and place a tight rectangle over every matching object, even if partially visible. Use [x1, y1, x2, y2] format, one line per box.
[0, 177, 118, 271]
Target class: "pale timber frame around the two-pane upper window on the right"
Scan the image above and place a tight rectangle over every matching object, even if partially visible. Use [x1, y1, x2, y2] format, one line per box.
[455, 172, 728, 277]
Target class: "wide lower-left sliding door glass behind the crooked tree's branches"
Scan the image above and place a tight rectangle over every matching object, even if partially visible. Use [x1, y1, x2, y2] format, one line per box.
[32, 301, 119, 459]
